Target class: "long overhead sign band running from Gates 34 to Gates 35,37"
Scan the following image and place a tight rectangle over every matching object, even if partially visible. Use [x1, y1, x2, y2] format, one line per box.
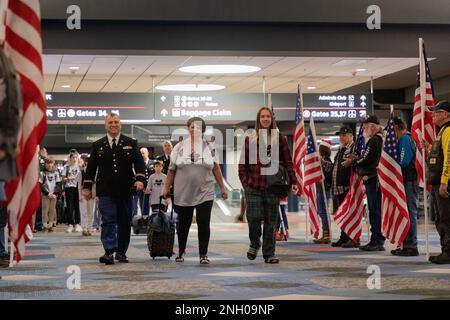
[46, 92, 373, 123]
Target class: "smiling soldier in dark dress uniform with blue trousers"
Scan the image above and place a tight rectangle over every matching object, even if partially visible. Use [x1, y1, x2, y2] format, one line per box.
[83, 114, 145, 264]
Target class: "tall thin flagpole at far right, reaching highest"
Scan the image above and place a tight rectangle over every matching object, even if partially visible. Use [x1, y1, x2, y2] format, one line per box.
[419, 38, 430, 260]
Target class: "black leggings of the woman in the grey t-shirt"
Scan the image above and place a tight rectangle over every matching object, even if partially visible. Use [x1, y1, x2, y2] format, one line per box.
[176, 200, 213, 256]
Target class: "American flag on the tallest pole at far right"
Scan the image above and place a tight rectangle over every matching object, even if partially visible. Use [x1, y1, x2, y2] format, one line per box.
[411, 39, 436, 187]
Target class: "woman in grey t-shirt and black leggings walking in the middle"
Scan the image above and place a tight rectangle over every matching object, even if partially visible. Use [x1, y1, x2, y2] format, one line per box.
[163, 117, 228, 264]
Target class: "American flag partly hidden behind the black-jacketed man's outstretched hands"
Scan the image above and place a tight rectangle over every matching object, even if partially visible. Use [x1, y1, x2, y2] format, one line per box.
[334, 125, 365, 242]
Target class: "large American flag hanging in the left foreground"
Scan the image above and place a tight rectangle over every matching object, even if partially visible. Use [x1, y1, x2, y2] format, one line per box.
[5, 0, 46, 262]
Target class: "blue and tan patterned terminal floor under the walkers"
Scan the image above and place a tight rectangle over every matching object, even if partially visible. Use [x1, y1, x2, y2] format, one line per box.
[0, 215, 450, 300]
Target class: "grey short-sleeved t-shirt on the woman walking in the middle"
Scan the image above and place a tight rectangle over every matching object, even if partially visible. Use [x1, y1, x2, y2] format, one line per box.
[169, 138, 219, 207]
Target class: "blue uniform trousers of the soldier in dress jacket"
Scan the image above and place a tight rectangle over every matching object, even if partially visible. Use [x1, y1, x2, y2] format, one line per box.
[98, 197, 131, 255]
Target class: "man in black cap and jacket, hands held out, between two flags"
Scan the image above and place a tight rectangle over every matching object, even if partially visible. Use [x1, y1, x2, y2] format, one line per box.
[343, 116, 386, 251]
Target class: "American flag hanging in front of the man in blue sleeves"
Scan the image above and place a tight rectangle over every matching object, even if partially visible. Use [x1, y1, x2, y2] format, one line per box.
[377, 111, 410, 247]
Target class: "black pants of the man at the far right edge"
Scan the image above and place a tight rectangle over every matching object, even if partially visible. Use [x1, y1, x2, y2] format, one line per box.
[431, 185, 450, 254]
